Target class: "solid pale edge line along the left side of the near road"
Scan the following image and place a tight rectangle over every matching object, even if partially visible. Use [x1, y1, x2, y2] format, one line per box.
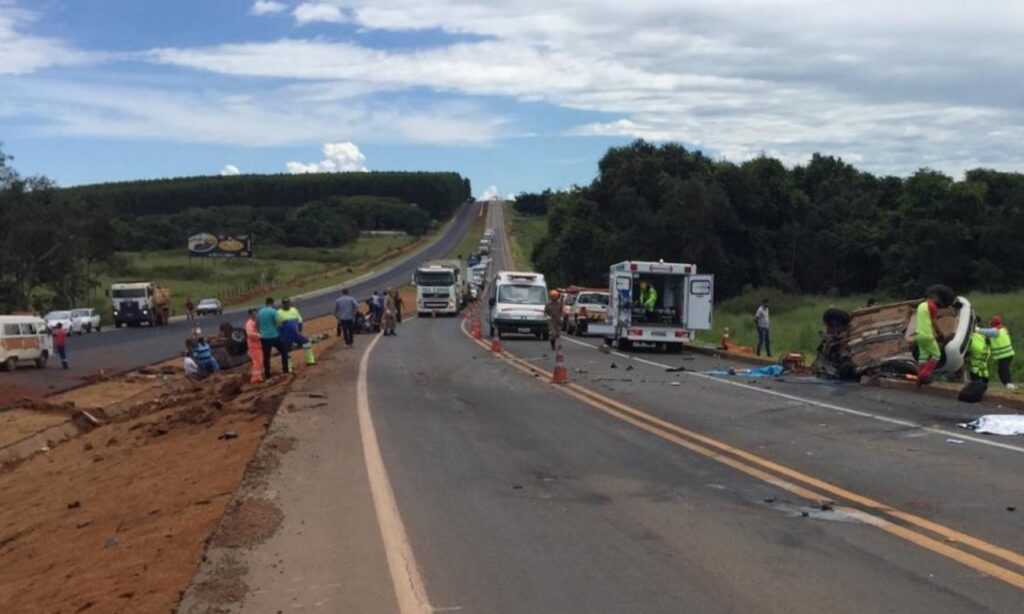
[355, 335, 432, 614]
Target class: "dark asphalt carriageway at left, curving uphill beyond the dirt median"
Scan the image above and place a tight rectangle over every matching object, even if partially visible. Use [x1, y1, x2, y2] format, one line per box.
[0, 204, 482, 392]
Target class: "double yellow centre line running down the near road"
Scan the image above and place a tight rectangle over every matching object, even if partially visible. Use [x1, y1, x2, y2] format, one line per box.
[462, 319, 1024, 589]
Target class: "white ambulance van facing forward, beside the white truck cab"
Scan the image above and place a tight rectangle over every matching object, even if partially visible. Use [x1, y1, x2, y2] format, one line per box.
[487, 271, 548, 339]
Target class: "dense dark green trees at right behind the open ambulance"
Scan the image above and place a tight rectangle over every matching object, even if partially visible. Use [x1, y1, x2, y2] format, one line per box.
[528, 141, 1024, 297]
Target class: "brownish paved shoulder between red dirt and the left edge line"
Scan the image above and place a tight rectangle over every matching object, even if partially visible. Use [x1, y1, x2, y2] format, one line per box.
[178, 337, 397, 614]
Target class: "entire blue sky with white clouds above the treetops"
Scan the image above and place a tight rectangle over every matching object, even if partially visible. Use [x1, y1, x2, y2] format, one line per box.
[0, 0, 1024, 194]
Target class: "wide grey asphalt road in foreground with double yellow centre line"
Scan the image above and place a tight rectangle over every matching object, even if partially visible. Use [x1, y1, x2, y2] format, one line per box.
[358, 207, 1024, 613]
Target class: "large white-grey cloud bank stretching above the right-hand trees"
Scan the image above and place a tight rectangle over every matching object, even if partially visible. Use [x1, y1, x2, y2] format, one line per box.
[152, 0, 1024, 172]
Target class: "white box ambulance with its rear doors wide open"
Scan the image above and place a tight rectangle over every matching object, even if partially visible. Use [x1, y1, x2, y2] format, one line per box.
[588, 260, 715, 352]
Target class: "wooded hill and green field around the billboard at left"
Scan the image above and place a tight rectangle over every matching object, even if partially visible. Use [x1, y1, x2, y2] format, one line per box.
[0, 144, 471, 320]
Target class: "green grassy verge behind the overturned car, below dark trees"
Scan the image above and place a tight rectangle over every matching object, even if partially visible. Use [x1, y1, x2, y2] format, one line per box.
[697, 290, 1024, 381]
